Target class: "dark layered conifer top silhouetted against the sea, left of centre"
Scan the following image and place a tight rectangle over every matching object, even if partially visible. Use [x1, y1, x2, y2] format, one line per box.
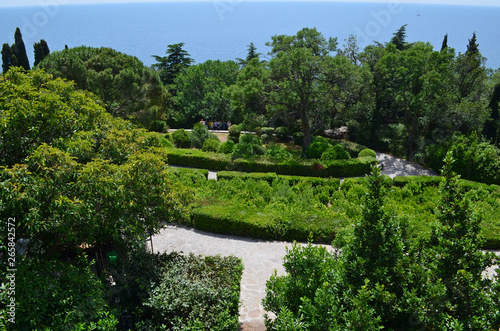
[153, 43, 194, 85]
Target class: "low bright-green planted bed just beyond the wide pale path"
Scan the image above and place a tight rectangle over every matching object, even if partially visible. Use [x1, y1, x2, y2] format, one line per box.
[172, 172, 500, 248]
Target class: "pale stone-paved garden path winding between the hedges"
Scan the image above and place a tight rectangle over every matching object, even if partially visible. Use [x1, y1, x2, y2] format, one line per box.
[152, 153, 494, 331]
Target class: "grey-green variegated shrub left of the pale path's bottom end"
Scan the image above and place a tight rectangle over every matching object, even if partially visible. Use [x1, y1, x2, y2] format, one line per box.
[144, 255, 243, 330]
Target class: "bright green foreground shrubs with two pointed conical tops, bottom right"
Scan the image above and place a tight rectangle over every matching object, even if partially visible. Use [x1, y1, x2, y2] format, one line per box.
[263, 163, 500, 331]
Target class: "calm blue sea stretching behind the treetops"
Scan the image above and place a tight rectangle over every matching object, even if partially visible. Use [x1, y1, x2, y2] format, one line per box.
[0, 0, 500, 69]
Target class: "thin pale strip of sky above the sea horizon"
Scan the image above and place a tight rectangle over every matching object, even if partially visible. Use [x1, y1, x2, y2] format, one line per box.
[0, 0, 500, 7]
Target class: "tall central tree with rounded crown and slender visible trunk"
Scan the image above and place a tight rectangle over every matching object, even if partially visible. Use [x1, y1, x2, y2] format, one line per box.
[267, 28, 337, 150]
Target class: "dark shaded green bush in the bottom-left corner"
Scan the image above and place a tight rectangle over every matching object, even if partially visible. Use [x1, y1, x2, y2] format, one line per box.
[15, 256, 118, 331]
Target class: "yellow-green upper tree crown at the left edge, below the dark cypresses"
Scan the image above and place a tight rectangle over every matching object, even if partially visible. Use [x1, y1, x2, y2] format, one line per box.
[0, 68, 113, 165]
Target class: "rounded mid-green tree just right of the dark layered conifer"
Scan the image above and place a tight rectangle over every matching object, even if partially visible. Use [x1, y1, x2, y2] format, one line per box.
[175, 60, 239, 127]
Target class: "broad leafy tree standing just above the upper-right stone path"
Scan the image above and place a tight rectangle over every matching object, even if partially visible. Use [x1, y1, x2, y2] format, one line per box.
[374, 42, 454, 160]
